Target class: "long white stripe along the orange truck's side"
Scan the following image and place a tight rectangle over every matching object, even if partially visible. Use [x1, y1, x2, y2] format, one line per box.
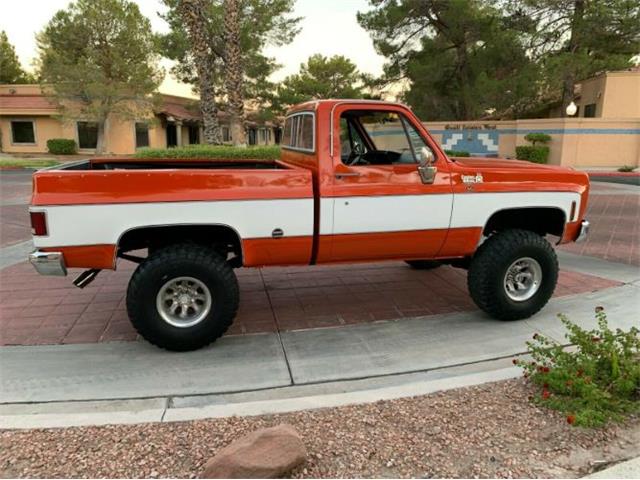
[31, 192, 580, 247]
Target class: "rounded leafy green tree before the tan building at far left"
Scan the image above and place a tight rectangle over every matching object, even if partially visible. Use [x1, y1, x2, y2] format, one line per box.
[37, 0, 163, 153]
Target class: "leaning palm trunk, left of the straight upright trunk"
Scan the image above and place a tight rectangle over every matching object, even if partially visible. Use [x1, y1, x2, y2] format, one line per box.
[178, 0, 222, 144]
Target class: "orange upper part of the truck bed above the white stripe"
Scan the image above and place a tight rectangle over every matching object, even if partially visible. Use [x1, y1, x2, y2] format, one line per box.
[31, 158, 313, 205]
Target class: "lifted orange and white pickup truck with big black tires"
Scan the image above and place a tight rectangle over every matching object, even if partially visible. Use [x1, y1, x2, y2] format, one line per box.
[30, 100, 589, 350]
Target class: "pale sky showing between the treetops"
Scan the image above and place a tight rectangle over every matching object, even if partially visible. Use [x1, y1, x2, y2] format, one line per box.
[0, 0, 384, 96]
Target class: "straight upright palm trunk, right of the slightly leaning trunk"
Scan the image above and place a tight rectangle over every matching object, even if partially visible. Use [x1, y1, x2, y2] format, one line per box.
[224, 0, 247, 146]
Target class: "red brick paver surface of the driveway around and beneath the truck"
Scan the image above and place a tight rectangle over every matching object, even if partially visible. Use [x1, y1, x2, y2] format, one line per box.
[0, 172, 640, 345]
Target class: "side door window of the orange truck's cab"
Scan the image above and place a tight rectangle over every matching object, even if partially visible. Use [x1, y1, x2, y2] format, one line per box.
[340, 110, 436, 166]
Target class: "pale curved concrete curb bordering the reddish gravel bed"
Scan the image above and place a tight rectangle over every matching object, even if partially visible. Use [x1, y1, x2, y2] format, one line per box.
[0, 367, 521, 429]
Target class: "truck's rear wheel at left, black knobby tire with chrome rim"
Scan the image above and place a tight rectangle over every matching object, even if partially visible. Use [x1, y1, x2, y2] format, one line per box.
[127, 244, 239, 351]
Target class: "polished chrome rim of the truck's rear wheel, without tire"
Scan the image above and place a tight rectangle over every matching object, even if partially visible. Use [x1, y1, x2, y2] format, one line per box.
[156, 277, 213, 328]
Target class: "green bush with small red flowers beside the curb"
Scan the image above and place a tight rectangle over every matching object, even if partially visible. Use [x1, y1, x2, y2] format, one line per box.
[513, 307, 640, 427]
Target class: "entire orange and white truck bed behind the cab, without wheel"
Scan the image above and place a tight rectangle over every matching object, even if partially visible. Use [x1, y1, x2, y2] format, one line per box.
[31, 158, 315, 268]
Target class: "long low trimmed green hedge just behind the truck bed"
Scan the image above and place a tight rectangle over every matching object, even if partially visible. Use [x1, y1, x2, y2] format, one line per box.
[135, 145, 280, 160]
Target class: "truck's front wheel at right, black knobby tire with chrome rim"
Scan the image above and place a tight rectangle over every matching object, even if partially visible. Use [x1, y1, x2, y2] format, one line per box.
[467, 230, 558, 320]
